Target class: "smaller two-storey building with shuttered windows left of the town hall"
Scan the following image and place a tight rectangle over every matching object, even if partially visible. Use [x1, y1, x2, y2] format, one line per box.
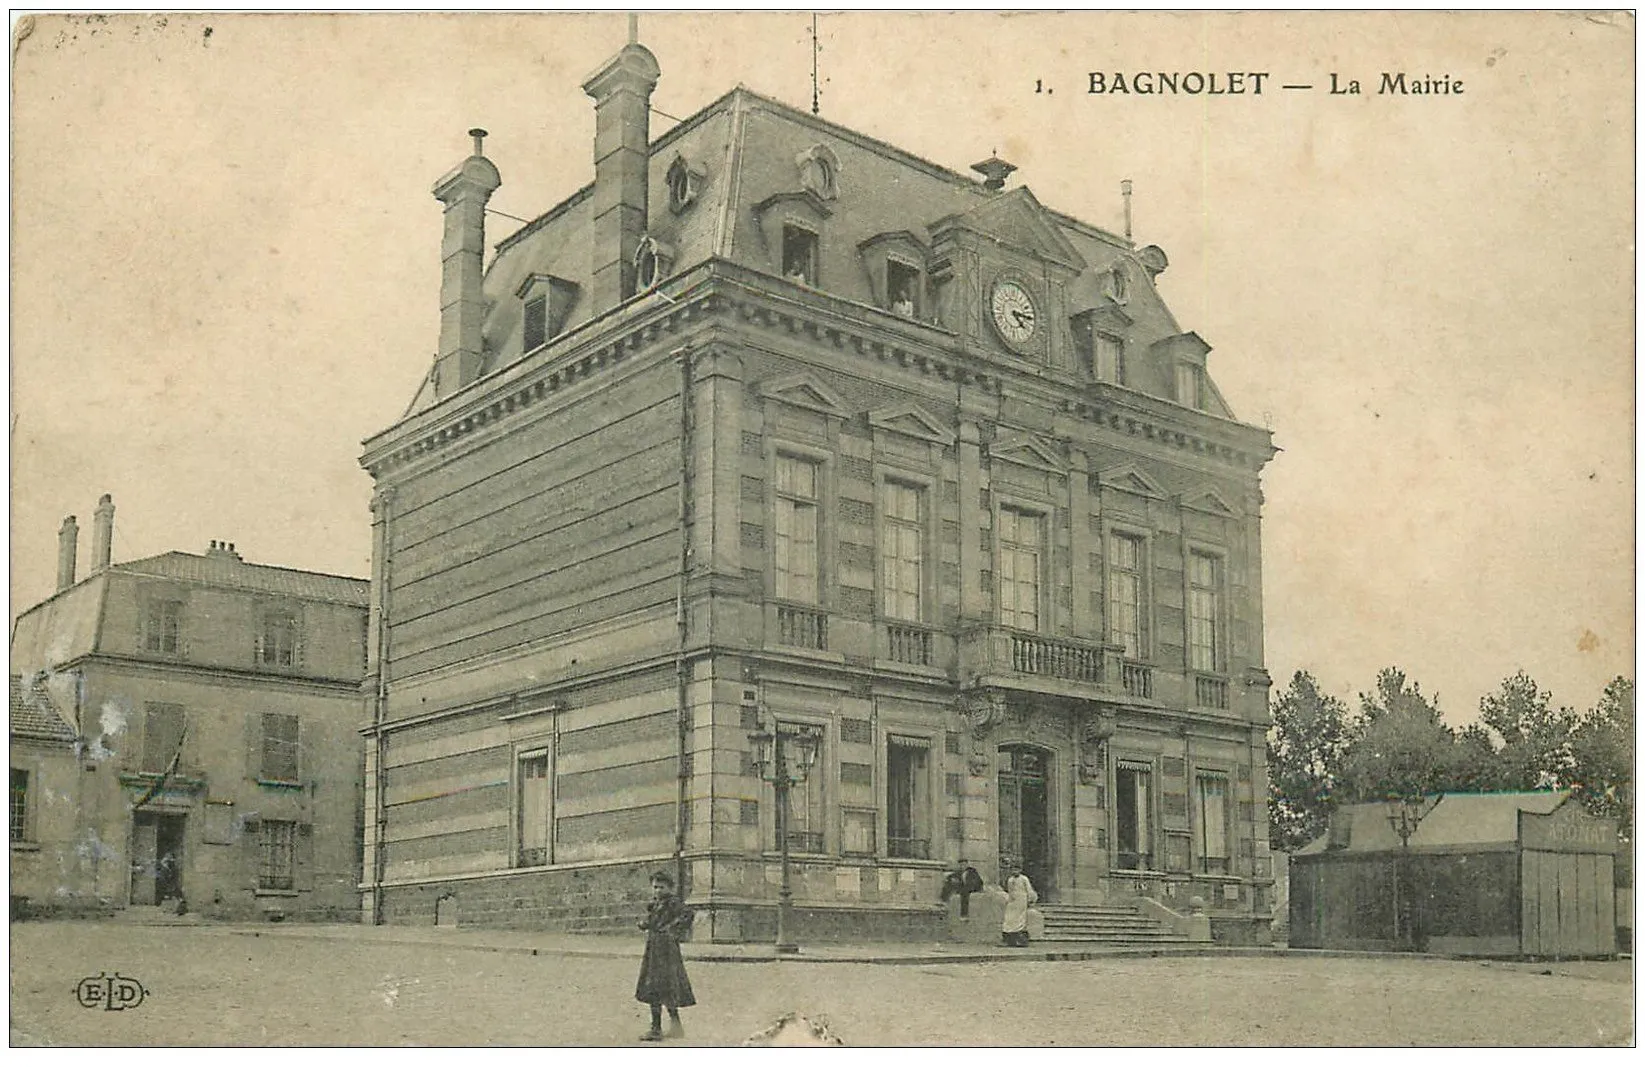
[12, 497, 367, 919]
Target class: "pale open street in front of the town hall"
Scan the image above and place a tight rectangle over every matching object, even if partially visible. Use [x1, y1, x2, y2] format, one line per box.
[12, 922, 1633, 1046]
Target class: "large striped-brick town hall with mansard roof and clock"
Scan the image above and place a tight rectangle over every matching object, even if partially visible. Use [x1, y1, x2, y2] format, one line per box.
[362, 35, 1275, 940]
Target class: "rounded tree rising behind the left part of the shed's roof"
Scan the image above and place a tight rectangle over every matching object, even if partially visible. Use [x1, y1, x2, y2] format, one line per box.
[1342, 667, 1457, 801]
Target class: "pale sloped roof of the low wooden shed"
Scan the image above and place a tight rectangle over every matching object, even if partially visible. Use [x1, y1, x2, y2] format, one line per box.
[1296, 789, 1571, 855]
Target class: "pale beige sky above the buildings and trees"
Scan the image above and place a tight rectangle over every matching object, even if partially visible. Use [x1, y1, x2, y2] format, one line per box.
[10, 12, 1635, 723]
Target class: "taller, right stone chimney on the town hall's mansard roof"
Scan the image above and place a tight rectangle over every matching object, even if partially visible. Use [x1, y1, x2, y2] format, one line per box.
[582, 33, 661, 314]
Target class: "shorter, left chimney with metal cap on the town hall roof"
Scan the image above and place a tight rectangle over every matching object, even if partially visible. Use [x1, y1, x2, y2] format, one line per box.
[434, 130, 503, 396]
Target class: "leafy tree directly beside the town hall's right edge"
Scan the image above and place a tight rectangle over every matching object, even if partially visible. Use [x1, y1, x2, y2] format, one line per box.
[1268, 671, 1349, 852]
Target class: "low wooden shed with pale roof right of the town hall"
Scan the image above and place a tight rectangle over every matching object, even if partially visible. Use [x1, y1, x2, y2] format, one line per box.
[1290, 792, 1617, 957]
